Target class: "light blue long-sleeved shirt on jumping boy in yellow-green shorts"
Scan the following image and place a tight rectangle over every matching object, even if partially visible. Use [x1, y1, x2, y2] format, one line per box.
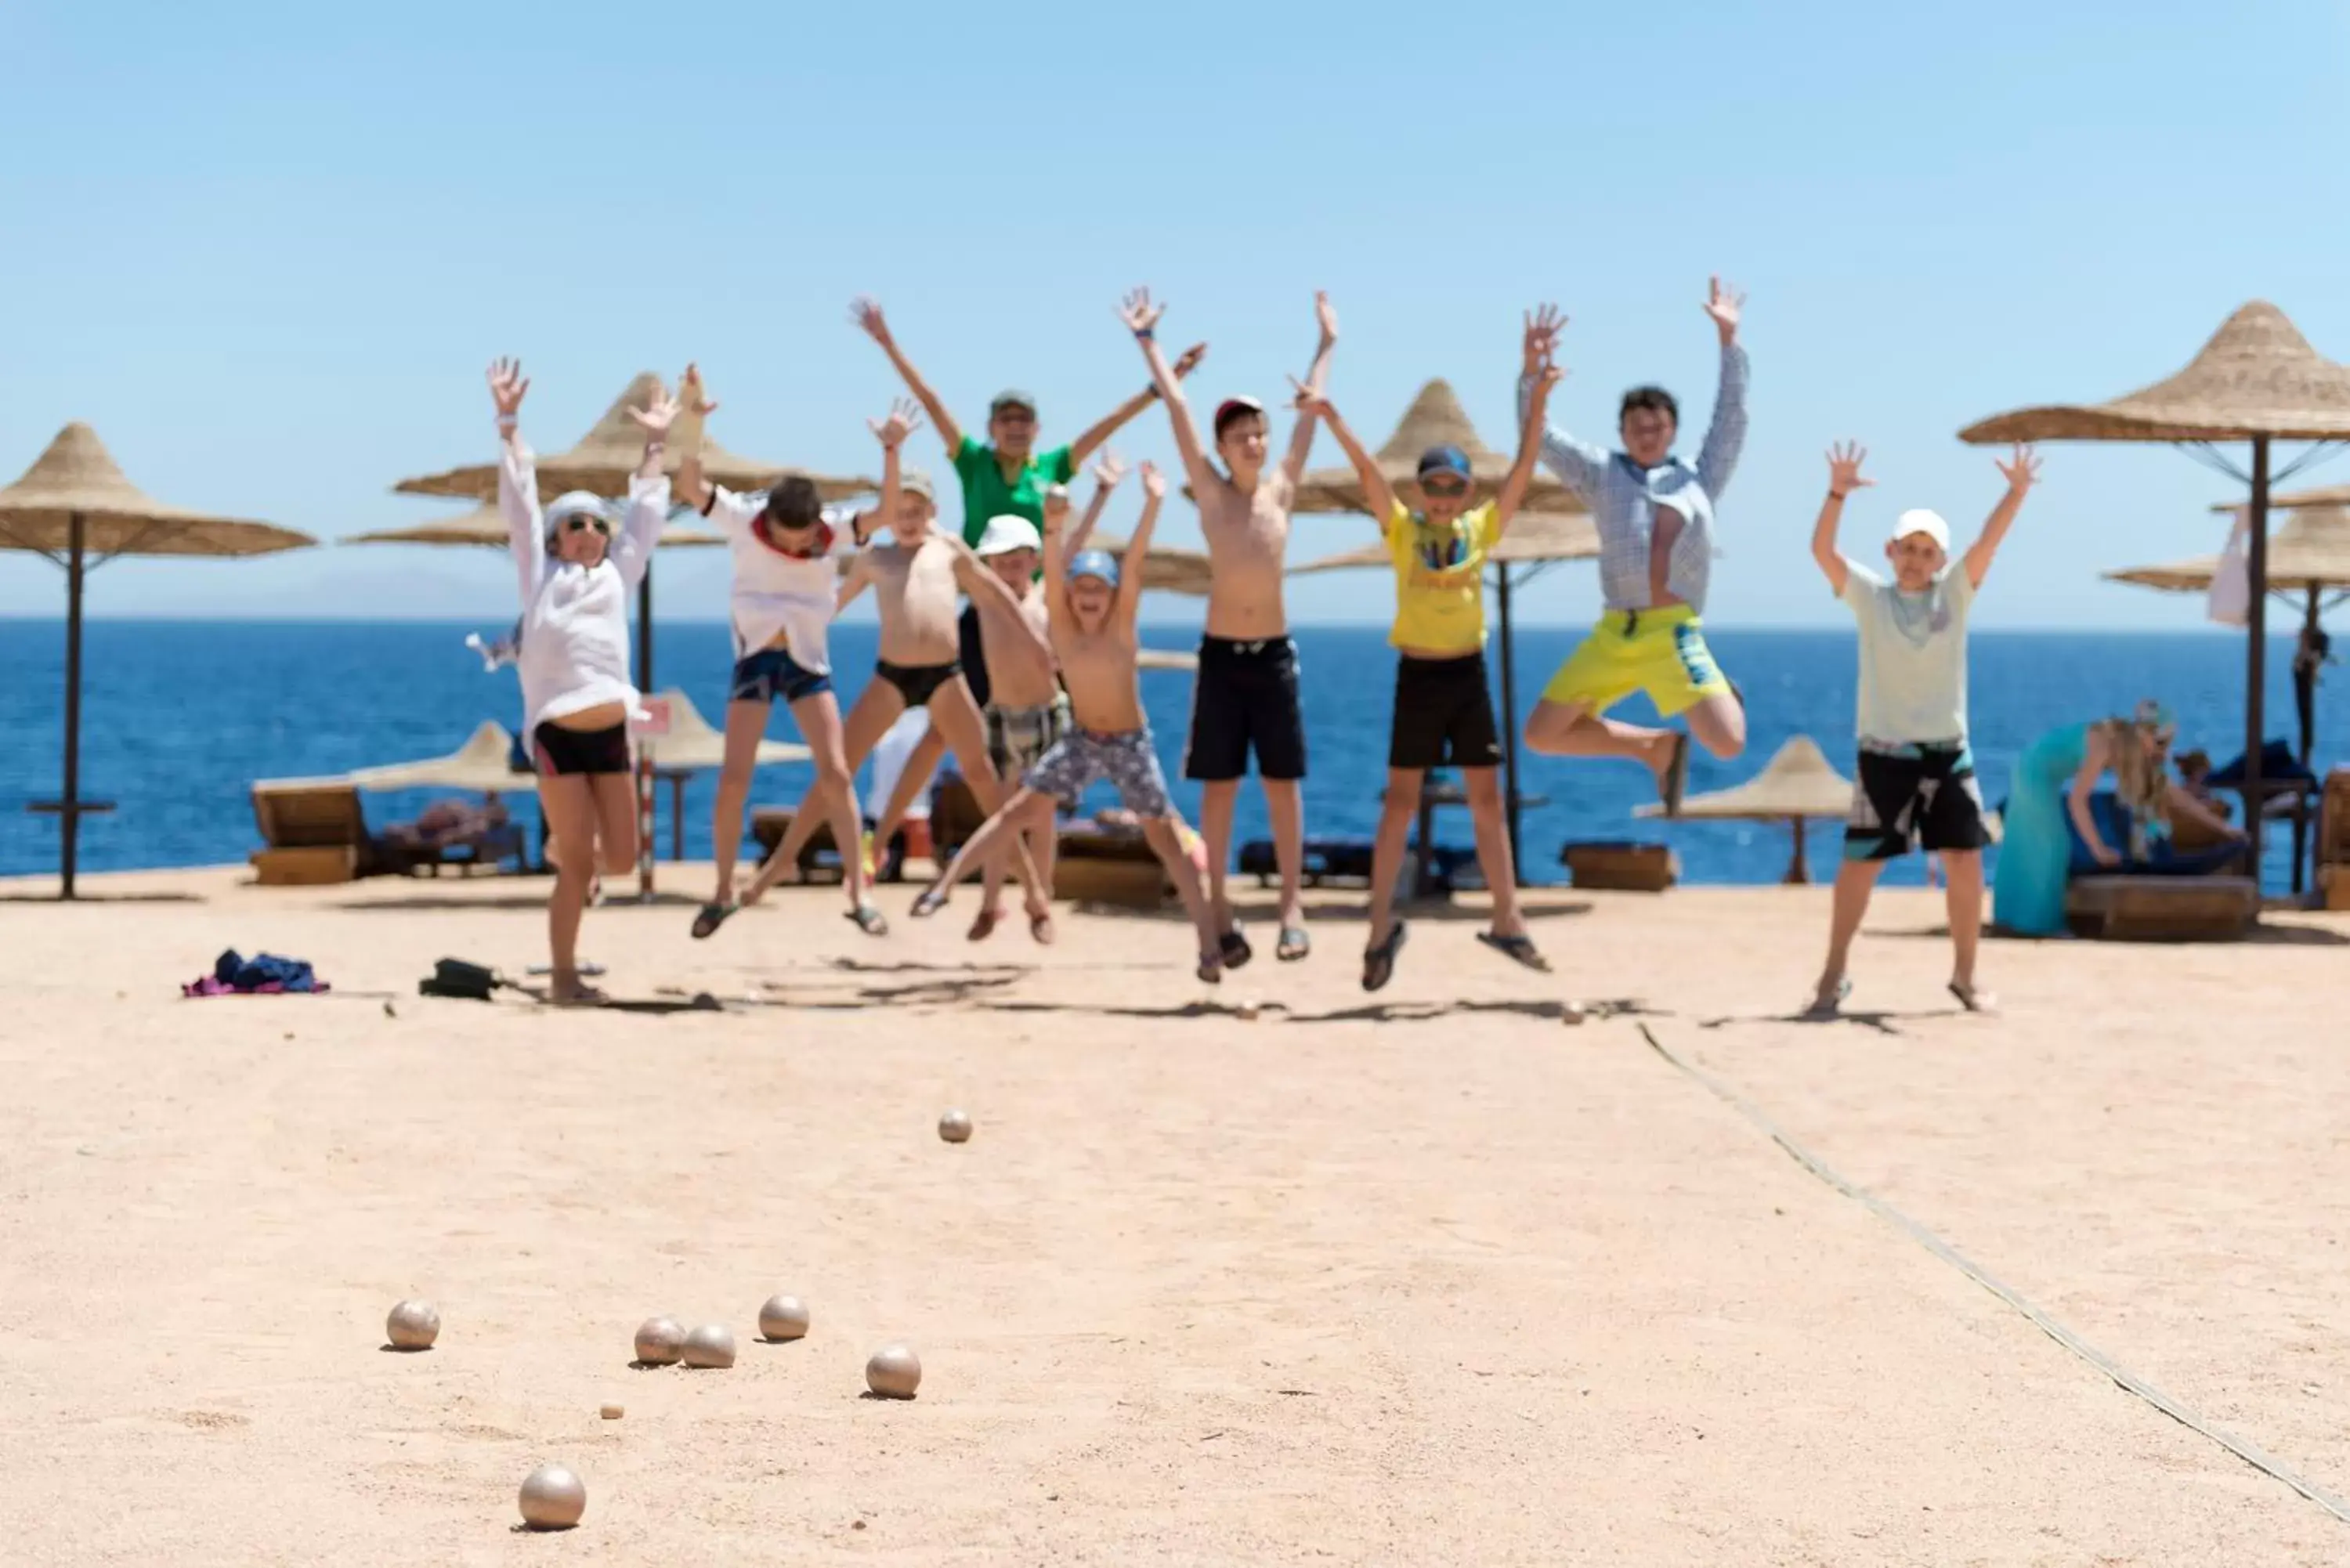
[1518, 343, 1746, 613]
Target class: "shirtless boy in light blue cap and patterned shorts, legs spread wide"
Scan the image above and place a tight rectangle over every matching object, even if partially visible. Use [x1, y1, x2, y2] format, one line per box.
[914, 463, 1224, 985]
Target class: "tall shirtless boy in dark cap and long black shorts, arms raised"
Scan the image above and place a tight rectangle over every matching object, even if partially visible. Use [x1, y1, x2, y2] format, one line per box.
[1119, 289, 1337, 969]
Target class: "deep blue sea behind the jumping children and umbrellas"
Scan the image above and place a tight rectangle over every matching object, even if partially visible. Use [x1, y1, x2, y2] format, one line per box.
[0, 620, 2350, 887]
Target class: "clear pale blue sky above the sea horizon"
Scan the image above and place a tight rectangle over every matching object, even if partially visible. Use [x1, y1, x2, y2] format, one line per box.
[0, 0, 2350, 625]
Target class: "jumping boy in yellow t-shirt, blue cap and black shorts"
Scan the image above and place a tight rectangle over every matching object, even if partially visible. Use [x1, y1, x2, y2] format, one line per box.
[1300, 345, 1558, 992]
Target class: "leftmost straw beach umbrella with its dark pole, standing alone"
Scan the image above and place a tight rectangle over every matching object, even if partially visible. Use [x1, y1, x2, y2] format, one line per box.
[0, 421, 317, 898]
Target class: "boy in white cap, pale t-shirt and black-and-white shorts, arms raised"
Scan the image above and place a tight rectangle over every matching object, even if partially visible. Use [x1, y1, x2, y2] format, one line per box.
[1810, 444, 2040, 1018]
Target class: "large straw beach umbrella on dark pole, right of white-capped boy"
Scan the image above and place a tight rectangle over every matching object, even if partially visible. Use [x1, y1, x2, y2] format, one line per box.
[1958, 301, 2350, 865]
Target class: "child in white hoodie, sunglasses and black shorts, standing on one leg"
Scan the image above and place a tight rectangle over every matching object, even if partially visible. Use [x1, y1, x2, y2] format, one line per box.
[489, 359, 677, 1006]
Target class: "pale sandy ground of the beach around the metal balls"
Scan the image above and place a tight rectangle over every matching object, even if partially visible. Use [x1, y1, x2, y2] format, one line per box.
[0, 868, 2350, 1566]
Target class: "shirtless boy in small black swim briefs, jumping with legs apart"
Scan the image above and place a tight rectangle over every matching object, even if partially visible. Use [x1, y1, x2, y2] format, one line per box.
[743, 406, 1053, 934]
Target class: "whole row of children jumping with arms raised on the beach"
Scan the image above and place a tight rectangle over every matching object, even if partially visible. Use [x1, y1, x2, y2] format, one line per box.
[489, 280, 2037, 1011]
